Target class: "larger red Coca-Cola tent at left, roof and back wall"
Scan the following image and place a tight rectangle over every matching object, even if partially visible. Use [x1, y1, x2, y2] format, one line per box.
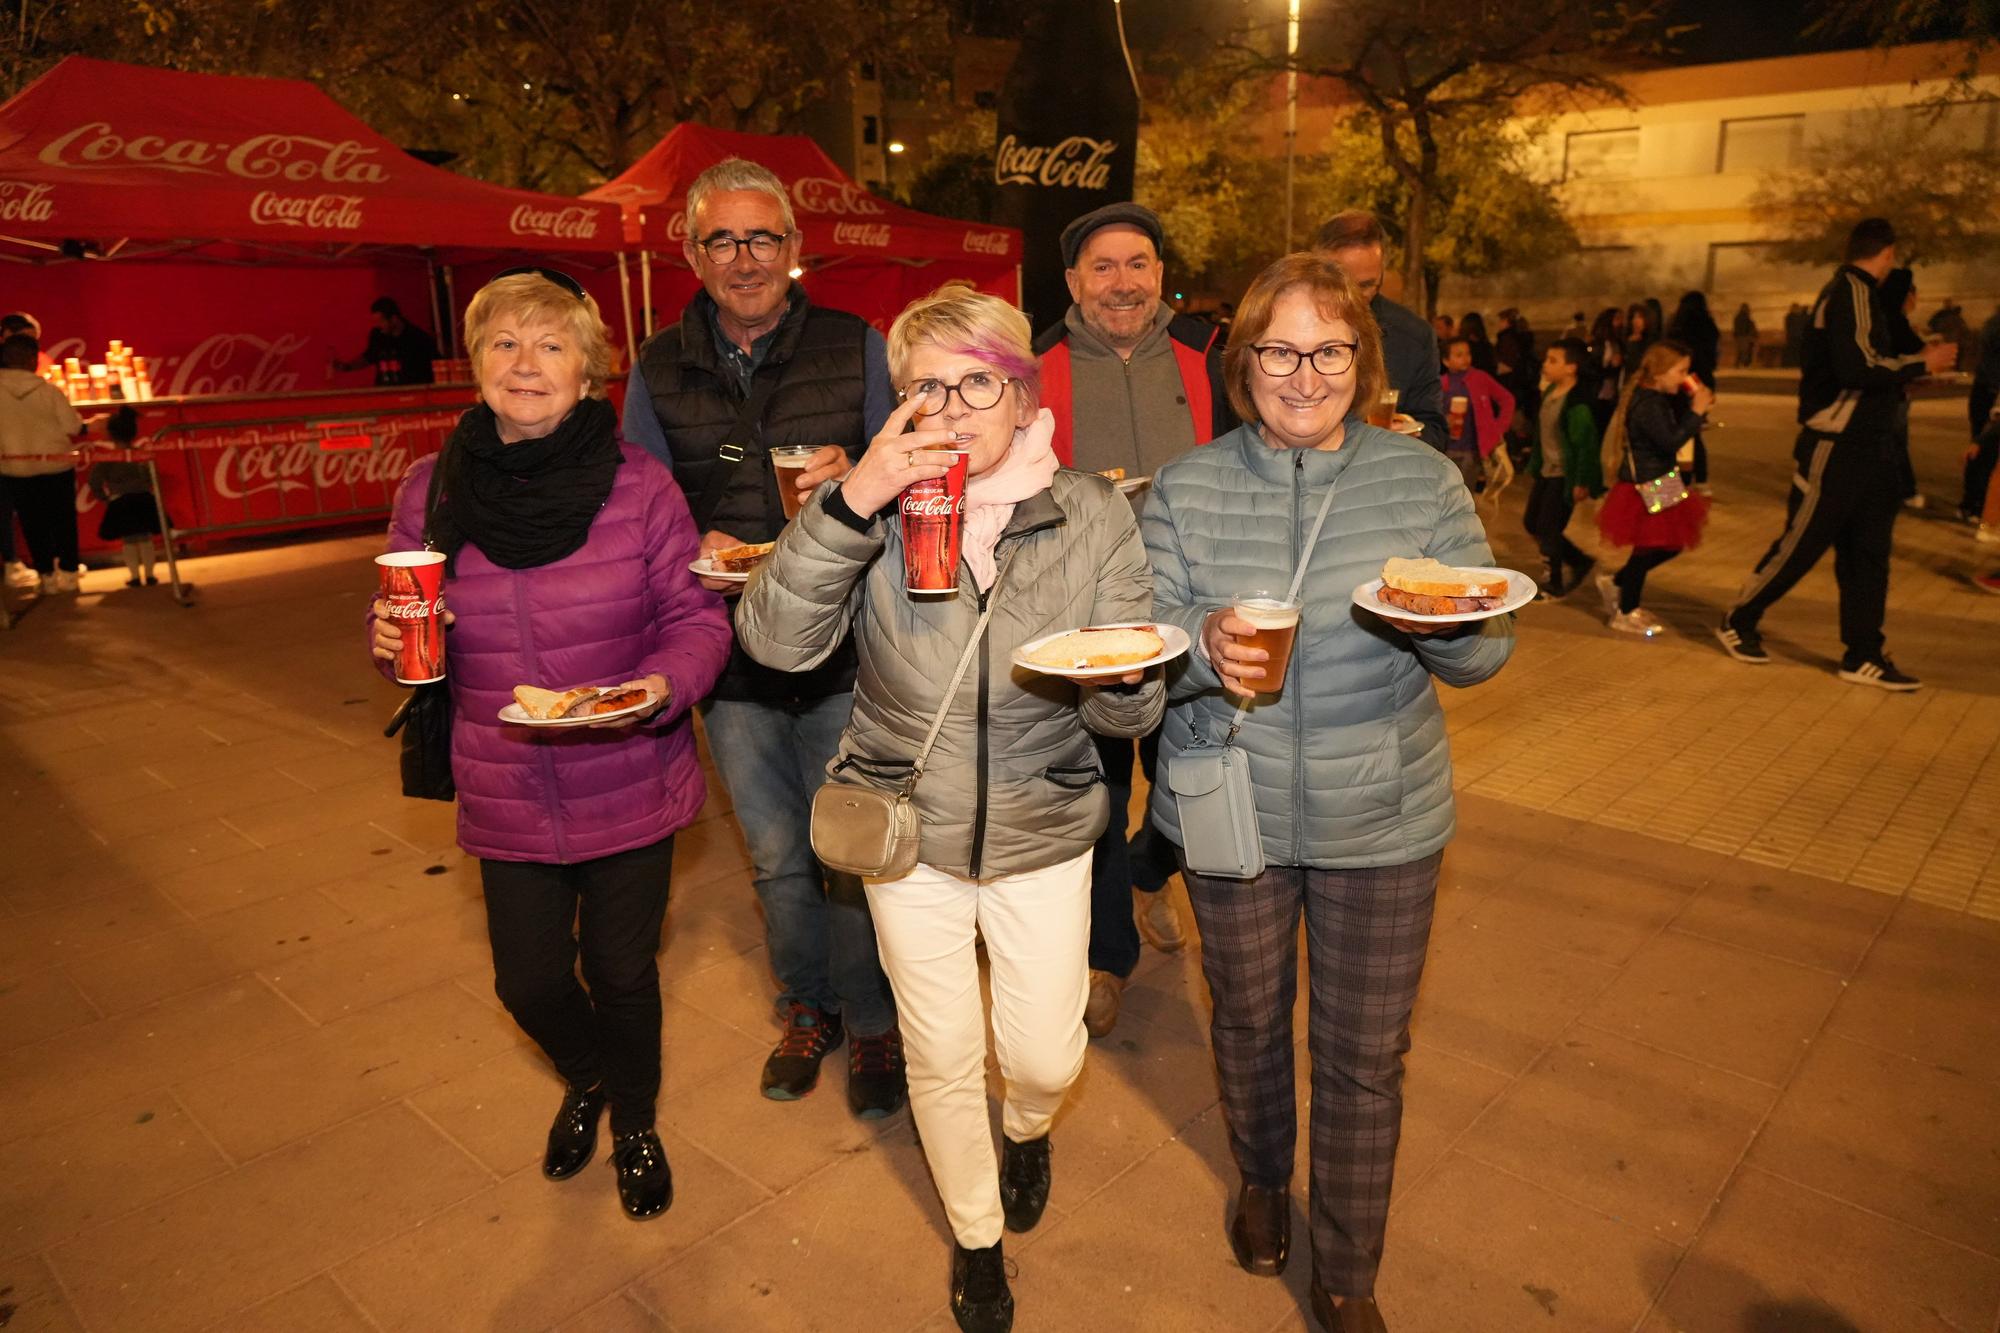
[0, 56, 632, 396]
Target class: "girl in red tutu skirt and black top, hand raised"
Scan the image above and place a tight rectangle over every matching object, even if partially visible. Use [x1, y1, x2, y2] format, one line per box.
[1598, 342, 1716, 638]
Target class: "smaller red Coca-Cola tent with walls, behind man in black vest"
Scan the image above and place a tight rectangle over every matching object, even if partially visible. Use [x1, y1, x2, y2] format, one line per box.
[584, 124, 1020, 324]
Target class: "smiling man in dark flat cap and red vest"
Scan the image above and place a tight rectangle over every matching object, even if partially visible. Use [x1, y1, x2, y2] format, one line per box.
[1034, 204, 1236, 1037]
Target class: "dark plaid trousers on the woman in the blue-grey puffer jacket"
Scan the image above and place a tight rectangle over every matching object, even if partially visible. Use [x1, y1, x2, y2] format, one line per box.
[1184, 853, 1444, 1297]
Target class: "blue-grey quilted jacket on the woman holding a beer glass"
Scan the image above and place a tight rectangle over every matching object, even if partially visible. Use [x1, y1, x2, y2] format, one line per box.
[1142, 420, 1514, 869]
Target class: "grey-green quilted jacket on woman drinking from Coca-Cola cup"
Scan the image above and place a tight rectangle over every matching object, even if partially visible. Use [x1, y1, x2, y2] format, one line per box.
[736, 470, 1168, 879]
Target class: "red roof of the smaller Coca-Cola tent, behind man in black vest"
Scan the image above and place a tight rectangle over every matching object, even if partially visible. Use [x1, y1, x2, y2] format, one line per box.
[584, 124, 1020, 266]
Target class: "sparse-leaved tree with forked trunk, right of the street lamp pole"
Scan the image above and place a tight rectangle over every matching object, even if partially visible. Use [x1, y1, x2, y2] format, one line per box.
[1228, 0, 1674, 306]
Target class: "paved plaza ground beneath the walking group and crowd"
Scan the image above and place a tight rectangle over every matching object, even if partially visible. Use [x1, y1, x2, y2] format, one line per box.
[0, 398, 2000, 1333]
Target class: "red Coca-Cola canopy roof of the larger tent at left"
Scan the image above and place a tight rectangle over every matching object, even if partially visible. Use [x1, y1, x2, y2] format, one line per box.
[0, 56, 624, 256]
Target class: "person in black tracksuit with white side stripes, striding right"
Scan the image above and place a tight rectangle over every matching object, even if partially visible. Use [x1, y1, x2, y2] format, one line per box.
[1716, 218, 1954, 691]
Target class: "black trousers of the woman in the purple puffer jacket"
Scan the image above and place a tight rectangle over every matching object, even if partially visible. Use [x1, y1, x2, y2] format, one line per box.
[480, 837, 674, 1135]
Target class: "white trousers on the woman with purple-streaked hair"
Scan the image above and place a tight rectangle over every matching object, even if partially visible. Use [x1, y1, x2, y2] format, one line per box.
[866, 853, 1090, 1249]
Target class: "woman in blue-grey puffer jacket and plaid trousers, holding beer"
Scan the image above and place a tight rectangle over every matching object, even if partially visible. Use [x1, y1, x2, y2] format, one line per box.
[1140, 254, 1514, 1333]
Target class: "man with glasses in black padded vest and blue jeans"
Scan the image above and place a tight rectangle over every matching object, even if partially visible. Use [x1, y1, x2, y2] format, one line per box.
[624, 158, 906, 1119]
